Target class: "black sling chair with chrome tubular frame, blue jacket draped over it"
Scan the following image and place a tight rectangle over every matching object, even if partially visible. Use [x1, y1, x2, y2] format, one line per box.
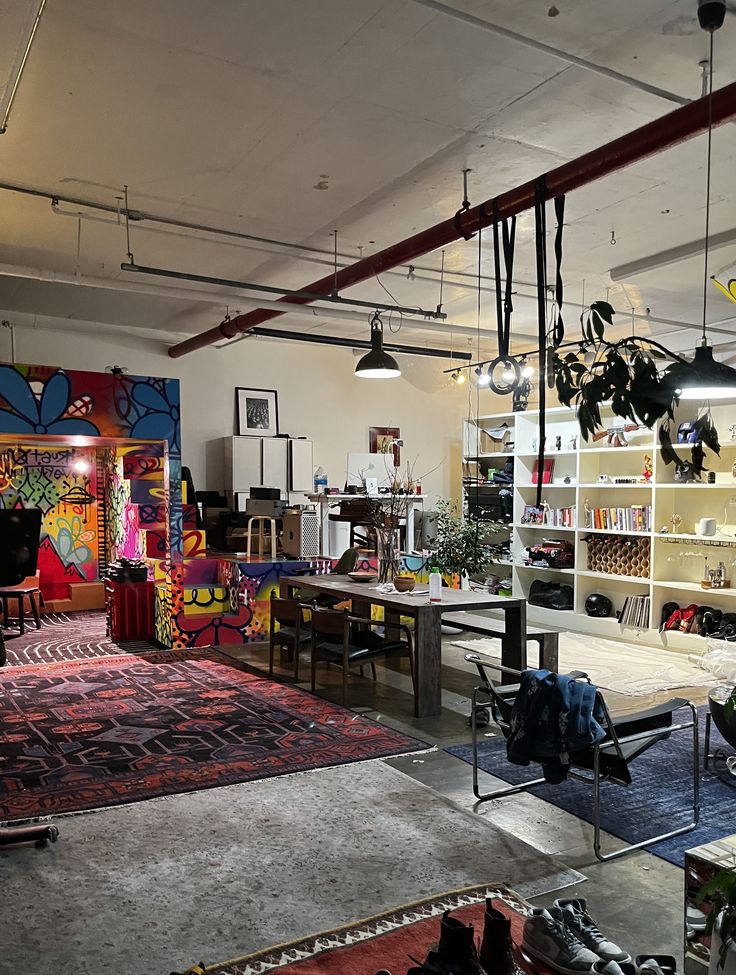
[465, 653, 700, 861]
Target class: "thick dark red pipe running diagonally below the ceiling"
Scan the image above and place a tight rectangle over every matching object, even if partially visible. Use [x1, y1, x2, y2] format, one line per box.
[169, 82, 736, 359]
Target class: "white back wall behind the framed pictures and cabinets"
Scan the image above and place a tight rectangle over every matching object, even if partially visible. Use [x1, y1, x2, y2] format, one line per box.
[0, 315, 467, 508]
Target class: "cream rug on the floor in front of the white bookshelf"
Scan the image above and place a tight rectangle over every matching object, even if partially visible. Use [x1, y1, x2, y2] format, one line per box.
[454, 633, 718, 697]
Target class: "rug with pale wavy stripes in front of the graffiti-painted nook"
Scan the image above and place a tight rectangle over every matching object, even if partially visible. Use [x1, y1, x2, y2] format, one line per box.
[3, 610, 158, 667]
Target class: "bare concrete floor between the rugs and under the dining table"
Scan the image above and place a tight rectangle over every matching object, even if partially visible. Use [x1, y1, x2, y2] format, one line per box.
[226, 637, 707, 964]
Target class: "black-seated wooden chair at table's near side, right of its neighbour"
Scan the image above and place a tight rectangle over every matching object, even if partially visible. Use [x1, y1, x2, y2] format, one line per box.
[311, 609, 416, 704]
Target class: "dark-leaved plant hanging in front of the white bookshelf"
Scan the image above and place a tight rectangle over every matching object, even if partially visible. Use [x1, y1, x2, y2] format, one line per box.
[553, 301, 720, 478]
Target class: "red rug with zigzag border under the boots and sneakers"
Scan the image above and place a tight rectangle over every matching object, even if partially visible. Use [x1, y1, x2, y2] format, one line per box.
[172, 884, 551, 975]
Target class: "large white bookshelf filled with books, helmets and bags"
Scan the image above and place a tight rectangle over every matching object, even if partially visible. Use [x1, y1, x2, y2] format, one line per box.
[463, 403, 736, 652]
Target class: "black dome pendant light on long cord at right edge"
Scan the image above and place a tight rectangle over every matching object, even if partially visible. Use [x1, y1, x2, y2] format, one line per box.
[676, 8, 736, 402]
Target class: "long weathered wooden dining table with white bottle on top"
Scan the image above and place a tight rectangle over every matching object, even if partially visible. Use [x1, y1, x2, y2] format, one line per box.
[280, 575, 526, 718]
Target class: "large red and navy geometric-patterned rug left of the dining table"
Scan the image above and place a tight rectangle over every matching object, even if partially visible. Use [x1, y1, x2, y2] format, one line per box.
[0, 649, 428, 821]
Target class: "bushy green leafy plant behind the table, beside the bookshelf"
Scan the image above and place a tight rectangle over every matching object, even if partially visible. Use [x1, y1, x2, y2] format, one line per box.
[430, 499, 508, 588]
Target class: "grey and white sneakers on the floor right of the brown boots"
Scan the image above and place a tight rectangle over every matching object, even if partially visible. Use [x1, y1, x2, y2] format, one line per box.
[523, 897, 676, 975]
